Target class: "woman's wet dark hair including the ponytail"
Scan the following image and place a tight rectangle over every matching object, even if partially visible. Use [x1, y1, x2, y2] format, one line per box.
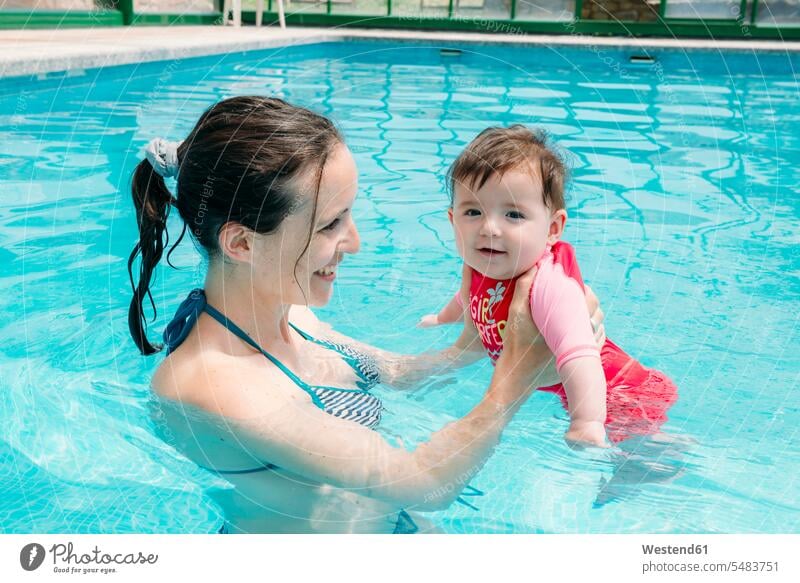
[128, 96, 342, 355]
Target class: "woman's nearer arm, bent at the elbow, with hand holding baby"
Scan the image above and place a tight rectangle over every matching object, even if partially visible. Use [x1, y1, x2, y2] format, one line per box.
[185, 268, 551, 510]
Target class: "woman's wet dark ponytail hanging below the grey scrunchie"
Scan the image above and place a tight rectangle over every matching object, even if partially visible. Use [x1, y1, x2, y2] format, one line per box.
[128, 159, 186, 356]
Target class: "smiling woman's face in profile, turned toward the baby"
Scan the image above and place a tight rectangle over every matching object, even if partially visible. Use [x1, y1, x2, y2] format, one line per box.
[252, 144, 361, 306]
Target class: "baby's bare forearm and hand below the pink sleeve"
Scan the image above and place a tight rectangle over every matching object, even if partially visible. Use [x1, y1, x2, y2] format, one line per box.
[558, 356, 608, 447]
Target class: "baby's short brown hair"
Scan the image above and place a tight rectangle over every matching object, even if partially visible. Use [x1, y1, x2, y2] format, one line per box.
[447, 124, 567, 210]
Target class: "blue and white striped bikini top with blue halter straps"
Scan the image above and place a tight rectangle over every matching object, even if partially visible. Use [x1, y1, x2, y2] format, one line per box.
[164, 288, 383, 429]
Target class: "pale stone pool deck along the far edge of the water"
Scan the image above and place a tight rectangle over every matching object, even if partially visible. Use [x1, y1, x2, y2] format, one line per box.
[0, 23, 800, 78]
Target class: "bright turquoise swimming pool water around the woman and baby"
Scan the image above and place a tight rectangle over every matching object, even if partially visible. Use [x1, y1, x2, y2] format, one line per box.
[0, 43, 800, 533]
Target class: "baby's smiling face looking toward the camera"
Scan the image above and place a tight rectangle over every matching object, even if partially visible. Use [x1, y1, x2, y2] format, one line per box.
[450, 170, 567, 279]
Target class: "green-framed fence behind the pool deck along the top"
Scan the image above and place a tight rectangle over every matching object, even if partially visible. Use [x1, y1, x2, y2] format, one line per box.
[0, 0, 800, 39]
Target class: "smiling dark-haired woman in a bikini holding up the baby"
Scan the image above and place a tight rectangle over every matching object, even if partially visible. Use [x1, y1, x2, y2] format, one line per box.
[129, 97, 602, 533]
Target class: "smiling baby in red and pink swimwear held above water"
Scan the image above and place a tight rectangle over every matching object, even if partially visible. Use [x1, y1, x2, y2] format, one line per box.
[420, 125, 677, 447]
